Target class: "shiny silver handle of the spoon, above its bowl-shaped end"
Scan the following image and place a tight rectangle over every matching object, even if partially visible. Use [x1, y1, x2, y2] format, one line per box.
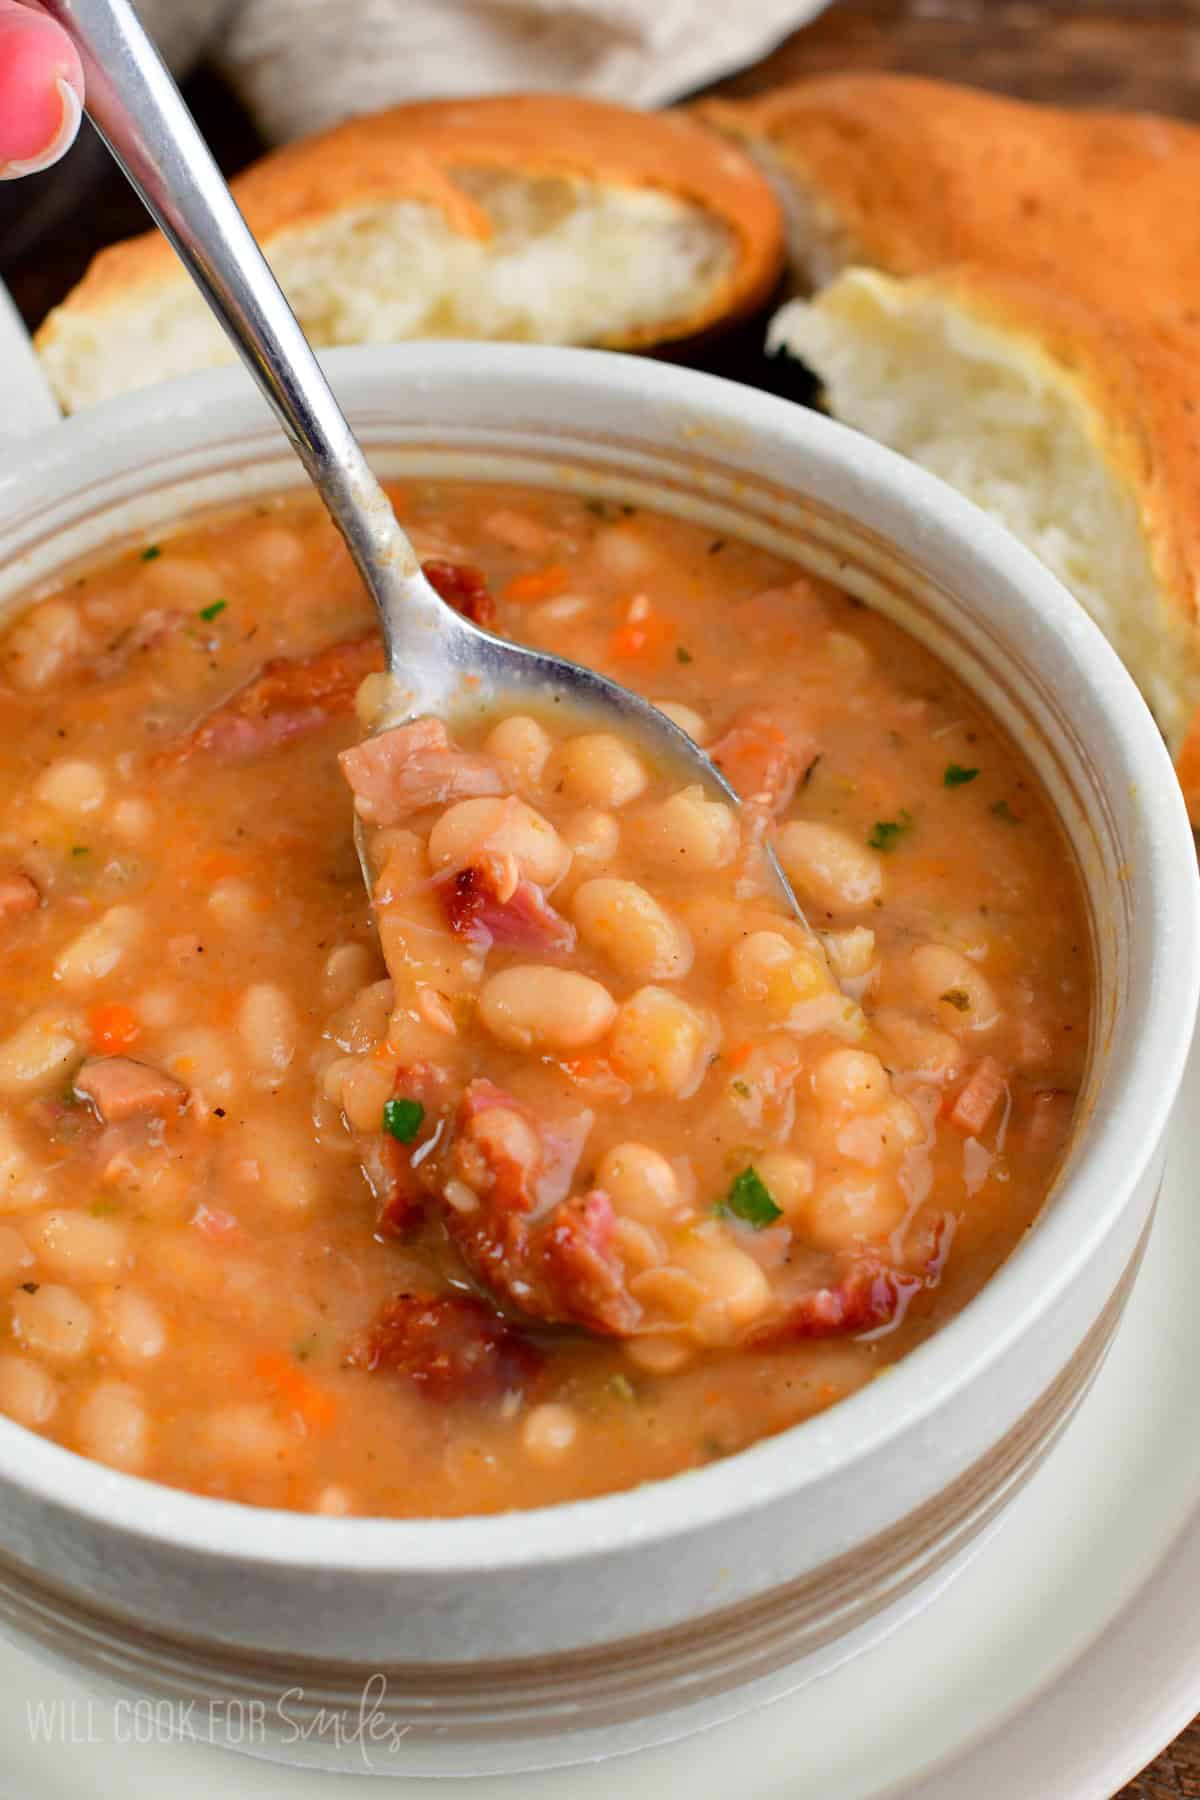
[40, 0, 424, 590]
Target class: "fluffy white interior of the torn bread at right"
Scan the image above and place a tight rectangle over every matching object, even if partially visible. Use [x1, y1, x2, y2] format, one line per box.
[768, 268, 1200, 751]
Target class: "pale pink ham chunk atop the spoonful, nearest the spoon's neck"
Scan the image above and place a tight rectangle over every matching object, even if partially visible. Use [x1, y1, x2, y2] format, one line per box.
[338, 718, 504, 824]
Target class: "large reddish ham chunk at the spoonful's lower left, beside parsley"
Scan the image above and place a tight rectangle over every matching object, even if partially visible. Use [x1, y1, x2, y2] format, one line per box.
[443, 1080, 640, 1337]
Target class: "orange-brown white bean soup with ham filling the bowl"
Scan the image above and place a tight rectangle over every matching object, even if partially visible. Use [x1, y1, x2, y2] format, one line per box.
[0, 482, 1092, 1516]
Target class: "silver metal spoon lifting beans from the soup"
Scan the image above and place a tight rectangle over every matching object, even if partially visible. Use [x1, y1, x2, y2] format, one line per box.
[41, 0, 802, 916]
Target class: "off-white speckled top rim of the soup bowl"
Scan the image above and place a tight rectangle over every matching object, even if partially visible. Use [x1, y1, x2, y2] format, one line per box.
[0, 342, 1200, 1575]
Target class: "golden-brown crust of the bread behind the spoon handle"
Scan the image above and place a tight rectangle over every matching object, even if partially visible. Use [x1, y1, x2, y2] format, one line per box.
[36, 94, 783, 347]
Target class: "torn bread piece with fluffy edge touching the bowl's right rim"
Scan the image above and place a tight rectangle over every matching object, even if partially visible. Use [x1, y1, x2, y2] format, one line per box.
[770, 266, 1200, 823]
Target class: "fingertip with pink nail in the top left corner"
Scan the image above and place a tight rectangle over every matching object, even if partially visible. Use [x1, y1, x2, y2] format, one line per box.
[0, 0, 83, 180]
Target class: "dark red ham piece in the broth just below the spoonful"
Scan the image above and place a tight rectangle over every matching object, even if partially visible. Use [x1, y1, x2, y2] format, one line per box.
[360, 1294, 543, 1402]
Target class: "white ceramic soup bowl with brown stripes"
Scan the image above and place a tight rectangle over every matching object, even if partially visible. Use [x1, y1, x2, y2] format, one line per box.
[0, 344, 1198, 1773]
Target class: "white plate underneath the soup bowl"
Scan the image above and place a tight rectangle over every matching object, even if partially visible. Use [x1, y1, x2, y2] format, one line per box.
[0, 1049, 1200, 1800]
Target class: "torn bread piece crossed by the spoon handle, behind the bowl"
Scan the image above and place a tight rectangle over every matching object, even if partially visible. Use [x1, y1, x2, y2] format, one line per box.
[36, 94, 783, 410]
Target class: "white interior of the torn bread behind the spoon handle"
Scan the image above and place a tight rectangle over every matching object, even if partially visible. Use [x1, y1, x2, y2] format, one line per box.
[41, 169, 736, 410]
